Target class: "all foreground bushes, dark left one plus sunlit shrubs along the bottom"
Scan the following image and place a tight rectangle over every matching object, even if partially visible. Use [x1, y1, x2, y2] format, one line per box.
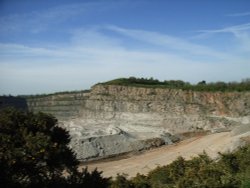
[0, 108, 250, 188]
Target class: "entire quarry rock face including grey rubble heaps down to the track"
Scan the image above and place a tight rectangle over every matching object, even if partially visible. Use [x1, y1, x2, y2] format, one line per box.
[27, 84, 250, 160]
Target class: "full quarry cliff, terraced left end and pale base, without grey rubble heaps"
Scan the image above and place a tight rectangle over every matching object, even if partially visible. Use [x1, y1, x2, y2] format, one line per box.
[27, 85, 250, 132]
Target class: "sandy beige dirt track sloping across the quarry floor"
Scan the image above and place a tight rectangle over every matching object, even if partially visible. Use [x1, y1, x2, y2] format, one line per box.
[82, 132, 232, 177]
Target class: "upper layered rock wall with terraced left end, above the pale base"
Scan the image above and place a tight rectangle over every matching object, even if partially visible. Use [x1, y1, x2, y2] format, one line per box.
[27, 85, 250, 122]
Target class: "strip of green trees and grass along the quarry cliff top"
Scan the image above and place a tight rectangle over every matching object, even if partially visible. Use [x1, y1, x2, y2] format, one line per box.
[101, 77, 250, 92]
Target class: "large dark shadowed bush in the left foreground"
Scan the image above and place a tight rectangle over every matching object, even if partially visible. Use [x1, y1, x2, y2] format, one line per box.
[0, 108, 109, 187]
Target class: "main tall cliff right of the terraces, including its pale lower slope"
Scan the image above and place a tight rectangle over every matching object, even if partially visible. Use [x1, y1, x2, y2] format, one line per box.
[80, 85, 250, 132]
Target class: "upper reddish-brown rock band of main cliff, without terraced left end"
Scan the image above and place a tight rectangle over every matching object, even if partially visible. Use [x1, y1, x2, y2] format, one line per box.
[89, 85, 250, 116]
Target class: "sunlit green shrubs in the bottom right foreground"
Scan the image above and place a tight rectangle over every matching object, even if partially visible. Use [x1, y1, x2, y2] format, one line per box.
[113, 145, 250, 188]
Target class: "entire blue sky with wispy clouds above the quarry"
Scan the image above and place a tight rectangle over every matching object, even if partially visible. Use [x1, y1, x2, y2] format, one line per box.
[0, 0, 250, 95]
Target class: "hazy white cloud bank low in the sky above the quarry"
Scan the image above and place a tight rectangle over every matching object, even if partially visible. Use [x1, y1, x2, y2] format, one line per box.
[0, 26, 250, 94]
